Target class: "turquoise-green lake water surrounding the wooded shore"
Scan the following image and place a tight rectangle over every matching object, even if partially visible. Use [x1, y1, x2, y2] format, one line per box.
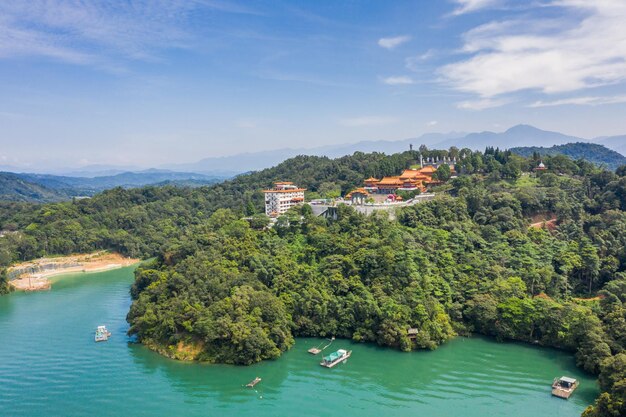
[0, 268, 598, 417]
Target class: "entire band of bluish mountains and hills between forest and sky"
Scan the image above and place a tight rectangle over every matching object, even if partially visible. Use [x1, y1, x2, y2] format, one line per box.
[0, 125, 626, 202]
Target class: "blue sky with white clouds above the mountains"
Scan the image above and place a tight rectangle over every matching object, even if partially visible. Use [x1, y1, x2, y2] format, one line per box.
[0, 0, 626, 170]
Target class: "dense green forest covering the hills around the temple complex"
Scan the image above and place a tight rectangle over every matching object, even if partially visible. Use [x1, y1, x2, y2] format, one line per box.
[0, 148, 626, 416]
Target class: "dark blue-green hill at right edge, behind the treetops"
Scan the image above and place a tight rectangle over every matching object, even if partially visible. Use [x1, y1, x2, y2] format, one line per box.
[511, 142, 626, 171]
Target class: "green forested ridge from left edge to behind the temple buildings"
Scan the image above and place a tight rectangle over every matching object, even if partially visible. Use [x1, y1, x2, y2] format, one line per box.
[0, 152, 424, 267]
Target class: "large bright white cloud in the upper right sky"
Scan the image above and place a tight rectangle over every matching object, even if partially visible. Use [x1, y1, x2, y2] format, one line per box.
[440, 0, 626, 108]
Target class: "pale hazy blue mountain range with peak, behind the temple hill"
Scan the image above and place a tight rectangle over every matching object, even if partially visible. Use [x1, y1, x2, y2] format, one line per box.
[164, 125, 626, 173]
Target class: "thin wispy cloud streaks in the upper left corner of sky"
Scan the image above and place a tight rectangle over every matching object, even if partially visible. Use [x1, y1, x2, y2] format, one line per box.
[0, 0, 256, 66]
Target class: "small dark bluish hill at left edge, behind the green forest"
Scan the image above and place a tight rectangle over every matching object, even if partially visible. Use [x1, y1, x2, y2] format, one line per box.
[0, 172, 68, 203]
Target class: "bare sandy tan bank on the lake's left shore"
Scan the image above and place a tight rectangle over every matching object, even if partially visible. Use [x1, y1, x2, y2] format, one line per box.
[7, 252, 139, 291]
